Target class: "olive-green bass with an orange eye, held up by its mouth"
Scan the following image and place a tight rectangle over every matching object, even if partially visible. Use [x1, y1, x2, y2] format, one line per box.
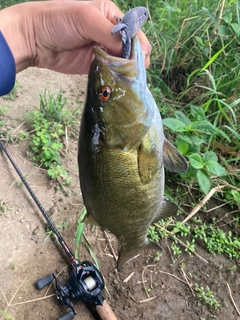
[78, 36, 188, 271]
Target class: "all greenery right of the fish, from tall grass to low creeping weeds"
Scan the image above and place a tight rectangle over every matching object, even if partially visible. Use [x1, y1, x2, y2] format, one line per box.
[115, 0, 240, 246]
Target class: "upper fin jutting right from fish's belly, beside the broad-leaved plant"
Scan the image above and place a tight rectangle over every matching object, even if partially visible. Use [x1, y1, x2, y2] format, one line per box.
[163, 138, 188, 173]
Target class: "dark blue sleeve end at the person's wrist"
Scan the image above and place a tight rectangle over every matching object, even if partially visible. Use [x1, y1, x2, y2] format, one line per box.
[0, 31, 16, 96]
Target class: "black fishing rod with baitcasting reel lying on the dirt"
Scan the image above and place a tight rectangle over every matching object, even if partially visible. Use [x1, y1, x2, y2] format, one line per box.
[0, 140, 117, 320]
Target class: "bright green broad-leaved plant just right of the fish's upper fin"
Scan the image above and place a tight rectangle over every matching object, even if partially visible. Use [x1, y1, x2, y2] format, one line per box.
[163, 110, 227, 194]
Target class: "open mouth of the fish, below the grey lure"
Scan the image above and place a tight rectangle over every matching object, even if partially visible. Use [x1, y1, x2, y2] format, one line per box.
[93, 37, 144, 77]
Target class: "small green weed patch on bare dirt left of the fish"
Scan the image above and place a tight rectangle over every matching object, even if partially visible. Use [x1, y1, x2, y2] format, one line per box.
[28, 90, 78, 184]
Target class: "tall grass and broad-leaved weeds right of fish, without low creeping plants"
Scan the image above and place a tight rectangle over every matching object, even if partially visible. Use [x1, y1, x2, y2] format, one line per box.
[115, 0, 240, 205]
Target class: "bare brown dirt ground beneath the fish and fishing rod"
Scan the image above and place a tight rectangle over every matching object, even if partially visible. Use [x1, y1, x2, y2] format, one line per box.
[0, 69, 240, 320]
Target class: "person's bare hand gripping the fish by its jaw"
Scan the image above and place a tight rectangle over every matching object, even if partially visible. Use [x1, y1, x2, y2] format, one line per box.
[0, 0, 151, 74]
